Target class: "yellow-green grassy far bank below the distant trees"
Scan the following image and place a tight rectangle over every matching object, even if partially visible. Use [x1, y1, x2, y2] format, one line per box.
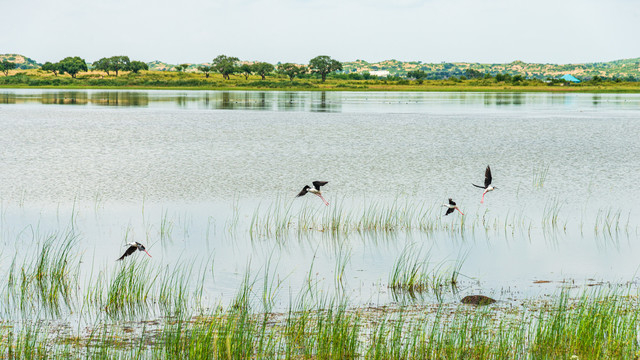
[0, 70, 640, 93]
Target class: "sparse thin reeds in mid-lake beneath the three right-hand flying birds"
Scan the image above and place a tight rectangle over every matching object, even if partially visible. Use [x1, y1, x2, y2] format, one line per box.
[249, 196, 584, 239]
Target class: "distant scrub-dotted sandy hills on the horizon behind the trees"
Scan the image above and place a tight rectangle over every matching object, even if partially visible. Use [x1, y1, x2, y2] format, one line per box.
[5, 54, 640, 80]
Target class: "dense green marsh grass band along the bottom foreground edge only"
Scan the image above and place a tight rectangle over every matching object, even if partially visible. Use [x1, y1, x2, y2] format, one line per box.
[0, 257, 640, 359]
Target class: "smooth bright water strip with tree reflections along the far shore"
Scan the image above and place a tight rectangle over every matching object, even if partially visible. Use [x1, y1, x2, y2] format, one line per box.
[0, 89, 640, 113]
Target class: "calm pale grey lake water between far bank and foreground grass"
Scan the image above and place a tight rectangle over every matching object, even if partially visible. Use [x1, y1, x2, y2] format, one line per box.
[0, 89, 640, 316]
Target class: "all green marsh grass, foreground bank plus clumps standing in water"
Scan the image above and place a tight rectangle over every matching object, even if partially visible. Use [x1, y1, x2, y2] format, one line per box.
[0, 198, 640, 359]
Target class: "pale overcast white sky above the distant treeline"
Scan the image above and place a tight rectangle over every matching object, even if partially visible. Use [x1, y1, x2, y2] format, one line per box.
[0, 0, 640, 64]
